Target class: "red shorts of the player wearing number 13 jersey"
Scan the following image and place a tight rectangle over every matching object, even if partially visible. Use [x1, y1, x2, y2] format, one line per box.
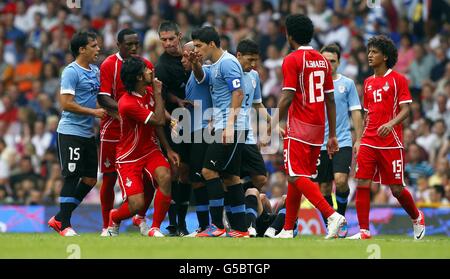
[283, 138, 321, 177]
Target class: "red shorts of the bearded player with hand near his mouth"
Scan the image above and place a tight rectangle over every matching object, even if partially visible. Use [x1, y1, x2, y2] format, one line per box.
[116, 150, 170, 200]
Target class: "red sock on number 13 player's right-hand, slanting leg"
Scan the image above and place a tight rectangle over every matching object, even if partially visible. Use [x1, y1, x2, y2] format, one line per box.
[295, 176, 335, 218]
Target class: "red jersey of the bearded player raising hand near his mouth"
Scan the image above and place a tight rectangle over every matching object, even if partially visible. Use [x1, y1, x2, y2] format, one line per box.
[116, 87, 159, 164]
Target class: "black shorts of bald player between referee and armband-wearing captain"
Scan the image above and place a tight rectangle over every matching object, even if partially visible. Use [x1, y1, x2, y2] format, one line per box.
[189, 130, 209, 182]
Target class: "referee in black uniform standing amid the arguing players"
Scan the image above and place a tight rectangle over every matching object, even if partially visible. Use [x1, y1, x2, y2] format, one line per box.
[155, 21, 192, 236]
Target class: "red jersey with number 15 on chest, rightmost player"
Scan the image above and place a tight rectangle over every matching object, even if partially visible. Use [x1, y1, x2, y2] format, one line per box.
[361, 69, 412, 149]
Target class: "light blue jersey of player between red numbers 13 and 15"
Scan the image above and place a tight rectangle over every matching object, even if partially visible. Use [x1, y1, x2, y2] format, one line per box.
[321, 75, 361, 150]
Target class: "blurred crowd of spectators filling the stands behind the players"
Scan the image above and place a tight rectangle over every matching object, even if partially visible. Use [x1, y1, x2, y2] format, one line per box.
[0, 0, 450, 209]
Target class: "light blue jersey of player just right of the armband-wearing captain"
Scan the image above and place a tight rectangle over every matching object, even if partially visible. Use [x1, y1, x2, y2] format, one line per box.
[243, 70, 262, 144]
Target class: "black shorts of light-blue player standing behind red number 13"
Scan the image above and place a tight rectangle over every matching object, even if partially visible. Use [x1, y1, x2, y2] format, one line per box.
[314, 146, 353, 183]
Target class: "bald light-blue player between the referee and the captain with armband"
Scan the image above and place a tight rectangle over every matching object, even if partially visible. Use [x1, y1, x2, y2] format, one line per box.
[181, 41, 212, 237]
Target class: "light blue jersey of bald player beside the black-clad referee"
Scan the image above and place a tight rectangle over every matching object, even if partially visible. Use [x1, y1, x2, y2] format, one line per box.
[186, 66, 212, 132]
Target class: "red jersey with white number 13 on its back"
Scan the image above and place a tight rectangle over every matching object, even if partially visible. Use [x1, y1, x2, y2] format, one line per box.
[282, 46, 334, 146]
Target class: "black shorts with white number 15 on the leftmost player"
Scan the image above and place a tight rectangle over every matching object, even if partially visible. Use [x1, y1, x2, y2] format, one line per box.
[57, 133, 98, 178]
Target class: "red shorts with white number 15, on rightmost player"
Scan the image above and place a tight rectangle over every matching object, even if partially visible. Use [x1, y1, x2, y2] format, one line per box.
[355, 145, 405, 186]
